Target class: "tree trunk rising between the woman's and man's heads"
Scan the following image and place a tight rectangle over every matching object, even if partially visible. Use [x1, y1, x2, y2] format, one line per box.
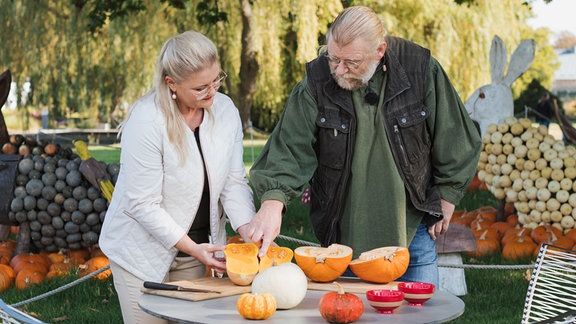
[236, 0, 260, 129]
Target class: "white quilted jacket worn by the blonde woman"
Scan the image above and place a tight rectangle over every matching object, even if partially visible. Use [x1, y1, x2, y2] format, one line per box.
[99, 92, 255, 281]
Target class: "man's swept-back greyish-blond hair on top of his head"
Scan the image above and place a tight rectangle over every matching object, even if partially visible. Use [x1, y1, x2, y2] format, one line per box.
[326, 6, 387, 48]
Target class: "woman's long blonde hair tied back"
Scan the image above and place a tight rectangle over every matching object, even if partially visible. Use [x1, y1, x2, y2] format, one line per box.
[120, 31, 218, 164]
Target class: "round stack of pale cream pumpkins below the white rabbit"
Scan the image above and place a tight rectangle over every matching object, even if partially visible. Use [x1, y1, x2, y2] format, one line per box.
[478, 117, 576, 233]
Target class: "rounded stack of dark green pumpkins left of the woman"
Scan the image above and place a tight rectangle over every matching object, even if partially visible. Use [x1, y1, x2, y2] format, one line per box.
[8, 144, 119, 252]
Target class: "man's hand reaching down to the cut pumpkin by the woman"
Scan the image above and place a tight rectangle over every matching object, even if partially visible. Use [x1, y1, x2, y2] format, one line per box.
[248, 200, 284, 256]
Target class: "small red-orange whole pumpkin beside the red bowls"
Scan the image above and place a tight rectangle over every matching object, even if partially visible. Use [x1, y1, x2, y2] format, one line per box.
[318, 282, 364, 323]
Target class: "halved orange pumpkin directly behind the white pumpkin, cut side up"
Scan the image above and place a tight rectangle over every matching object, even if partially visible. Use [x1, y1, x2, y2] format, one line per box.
[294, 244, 352, 282]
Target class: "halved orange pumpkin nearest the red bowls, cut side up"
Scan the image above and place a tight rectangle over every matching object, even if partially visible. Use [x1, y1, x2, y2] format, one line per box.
[350, 246, 410, 283]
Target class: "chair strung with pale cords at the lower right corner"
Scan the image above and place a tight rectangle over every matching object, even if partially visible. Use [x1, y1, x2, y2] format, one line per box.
[522, 244, 576, 324]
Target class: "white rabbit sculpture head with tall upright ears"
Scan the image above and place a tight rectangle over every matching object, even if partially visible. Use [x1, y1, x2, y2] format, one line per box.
[464, 36, 535, 135]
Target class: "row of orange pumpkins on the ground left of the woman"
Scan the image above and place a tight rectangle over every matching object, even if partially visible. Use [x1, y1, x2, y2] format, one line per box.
[0, 240, 111, 292]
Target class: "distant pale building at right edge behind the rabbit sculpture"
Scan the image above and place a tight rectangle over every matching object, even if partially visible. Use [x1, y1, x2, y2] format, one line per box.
[552, 46, 576, 98]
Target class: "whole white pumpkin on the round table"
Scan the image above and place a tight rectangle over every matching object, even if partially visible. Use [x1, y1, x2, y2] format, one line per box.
[251, 261, 308, 309]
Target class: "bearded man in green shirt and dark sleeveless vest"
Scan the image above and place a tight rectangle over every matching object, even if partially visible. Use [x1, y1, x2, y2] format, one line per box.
[248, 6, 481, 284]
